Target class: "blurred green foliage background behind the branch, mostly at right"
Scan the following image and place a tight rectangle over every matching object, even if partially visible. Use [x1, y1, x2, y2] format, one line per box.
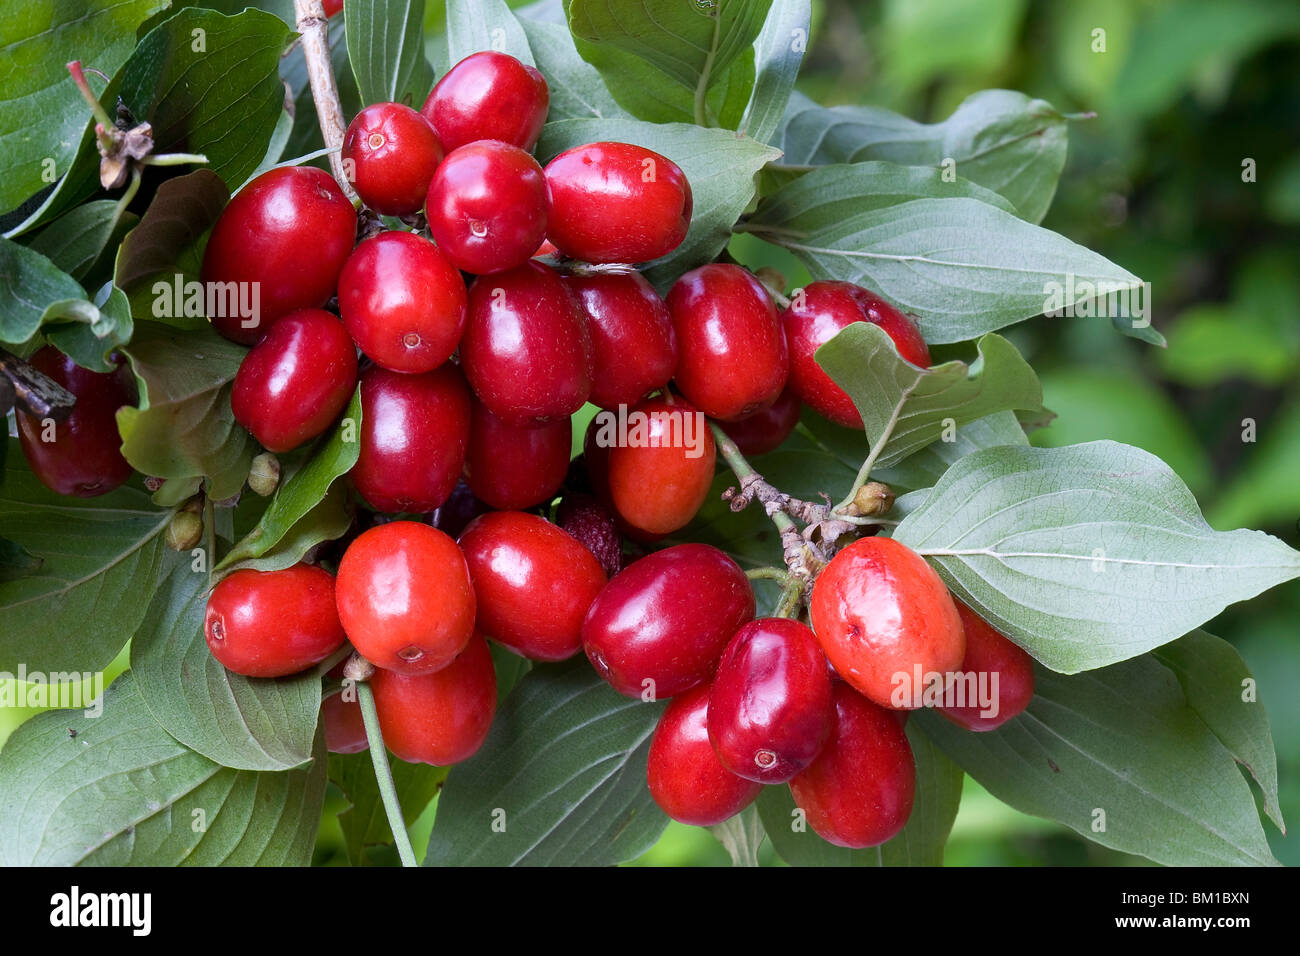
[0, 0, 1300, 865]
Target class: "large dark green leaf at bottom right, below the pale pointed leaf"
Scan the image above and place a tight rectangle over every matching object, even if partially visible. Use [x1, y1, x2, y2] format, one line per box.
[913, 657, 1275, 866]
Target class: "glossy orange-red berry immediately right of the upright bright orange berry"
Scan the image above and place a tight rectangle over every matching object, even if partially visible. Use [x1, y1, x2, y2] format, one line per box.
[459, 511, 605, 661]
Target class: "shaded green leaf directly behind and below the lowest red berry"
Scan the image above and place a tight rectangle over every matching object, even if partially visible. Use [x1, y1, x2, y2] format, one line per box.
[758, 721, 962, 866]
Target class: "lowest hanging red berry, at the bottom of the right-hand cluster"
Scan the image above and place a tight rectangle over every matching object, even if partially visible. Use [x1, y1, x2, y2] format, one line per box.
[790, 682, 917, 849]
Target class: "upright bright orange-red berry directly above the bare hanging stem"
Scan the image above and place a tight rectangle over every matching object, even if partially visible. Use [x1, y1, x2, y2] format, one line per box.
[337, 522, 475, 674]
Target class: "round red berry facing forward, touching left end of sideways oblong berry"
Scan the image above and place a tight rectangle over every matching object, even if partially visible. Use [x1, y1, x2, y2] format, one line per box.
[425, 139, 546, 276]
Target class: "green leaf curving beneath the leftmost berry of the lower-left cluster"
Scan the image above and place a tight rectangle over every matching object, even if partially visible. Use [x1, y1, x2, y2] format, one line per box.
[131, 551, 321, 770]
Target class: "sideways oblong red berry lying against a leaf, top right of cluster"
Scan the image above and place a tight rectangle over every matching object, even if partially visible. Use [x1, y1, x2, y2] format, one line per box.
[546, 143, 692, 263]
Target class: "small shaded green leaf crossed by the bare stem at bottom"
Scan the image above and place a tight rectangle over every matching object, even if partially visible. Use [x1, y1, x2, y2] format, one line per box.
[329, 750, 447, 866]
